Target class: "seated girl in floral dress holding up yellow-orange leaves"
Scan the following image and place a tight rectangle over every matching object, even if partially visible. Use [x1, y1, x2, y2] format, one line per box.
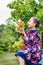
[15, 17, 42, 65]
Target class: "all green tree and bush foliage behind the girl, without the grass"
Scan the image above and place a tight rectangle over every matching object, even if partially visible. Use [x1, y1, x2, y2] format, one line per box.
[0, 0, 43, 51]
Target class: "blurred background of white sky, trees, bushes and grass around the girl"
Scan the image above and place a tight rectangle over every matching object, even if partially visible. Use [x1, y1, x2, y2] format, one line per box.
[0, 0, 43, 65]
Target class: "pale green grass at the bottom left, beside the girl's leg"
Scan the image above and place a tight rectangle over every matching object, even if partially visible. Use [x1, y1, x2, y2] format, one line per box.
[0, 52, 19, 65]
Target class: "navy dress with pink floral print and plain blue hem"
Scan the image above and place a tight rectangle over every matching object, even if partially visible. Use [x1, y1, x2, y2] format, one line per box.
[15, 29, 42, 65]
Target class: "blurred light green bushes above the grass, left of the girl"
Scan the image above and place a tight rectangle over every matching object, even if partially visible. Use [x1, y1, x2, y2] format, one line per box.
[0, 22, 20, 52]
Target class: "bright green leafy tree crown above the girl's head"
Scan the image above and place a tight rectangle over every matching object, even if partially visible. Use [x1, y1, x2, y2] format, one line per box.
[7, 0, 43, 29]
